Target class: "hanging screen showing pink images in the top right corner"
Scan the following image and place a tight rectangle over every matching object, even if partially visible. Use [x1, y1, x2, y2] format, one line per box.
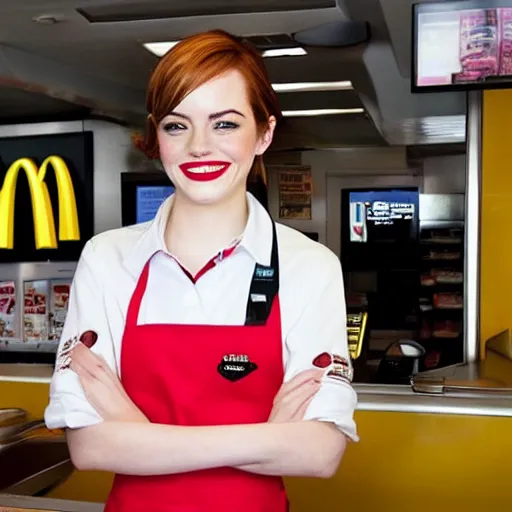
[411, 0, 512, 92]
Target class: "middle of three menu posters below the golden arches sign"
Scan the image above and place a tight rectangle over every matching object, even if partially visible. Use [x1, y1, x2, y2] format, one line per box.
[23, 280, 50, 341]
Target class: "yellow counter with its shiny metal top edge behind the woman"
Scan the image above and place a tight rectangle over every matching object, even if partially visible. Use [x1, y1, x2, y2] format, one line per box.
[0, 354, 512, 512]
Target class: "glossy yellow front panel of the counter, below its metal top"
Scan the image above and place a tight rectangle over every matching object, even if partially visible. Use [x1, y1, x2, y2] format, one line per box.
[0, 383, 512, 512]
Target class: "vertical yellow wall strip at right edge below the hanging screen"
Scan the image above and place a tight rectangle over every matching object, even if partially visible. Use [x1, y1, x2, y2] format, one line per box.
[480, 90, 512, 353]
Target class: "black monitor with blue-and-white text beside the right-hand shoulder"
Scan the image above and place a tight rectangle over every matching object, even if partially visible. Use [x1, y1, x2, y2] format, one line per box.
[341, 187, 419, 270]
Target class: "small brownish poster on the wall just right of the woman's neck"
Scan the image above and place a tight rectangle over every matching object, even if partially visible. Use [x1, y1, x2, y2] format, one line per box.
[278, 167, 313, 220]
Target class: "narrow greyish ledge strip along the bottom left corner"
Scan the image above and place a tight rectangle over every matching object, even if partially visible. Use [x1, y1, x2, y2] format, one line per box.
[0, 494, 104, 512]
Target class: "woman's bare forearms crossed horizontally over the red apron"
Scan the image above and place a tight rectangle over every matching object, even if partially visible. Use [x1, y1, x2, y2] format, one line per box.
[67, 422, 344, 476]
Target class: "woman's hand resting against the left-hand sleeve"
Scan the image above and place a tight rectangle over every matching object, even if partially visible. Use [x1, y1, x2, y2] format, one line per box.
[70, 343, 148, 423]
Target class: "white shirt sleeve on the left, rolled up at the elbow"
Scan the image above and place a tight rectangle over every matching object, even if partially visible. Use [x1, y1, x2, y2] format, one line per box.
[45, 241, 115, 429]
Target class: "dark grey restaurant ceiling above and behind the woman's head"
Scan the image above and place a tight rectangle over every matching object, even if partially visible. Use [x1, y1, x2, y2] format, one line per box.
[0, 0, 465, 149]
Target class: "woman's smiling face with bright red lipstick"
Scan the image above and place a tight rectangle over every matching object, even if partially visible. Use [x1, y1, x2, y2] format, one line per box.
[158, 71, 275, 204]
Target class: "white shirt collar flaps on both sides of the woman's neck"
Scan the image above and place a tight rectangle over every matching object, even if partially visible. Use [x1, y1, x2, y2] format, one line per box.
[124, 192, 272, 276]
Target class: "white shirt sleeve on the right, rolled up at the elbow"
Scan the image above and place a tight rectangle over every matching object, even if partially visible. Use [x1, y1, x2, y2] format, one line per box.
[285, 248, 359, 442]
